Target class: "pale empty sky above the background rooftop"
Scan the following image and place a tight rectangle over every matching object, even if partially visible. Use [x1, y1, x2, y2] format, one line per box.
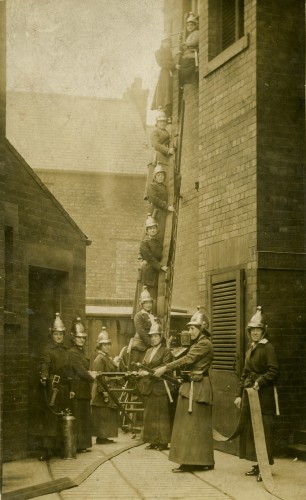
[7, 0, 163, 123]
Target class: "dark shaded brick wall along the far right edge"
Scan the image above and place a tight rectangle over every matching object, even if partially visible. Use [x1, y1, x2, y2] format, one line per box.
[257, 0, 306, 434]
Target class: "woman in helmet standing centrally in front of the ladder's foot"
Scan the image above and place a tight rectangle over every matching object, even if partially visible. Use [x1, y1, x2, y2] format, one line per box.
[138, 318, 173, 451]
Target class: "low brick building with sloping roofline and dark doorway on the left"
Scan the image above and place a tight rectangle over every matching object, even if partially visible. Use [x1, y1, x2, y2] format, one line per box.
[0, 2, 89, 463]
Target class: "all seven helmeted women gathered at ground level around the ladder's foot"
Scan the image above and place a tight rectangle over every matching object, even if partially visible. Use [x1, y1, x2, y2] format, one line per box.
[39, 300, 279, 481]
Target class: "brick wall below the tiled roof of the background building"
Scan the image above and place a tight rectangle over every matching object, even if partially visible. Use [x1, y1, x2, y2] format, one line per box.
[39, 171, 148, 302]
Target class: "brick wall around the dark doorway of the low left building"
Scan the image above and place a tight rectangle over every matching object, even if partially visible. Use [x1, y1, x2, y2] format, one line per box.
[0, 142, 86, 460]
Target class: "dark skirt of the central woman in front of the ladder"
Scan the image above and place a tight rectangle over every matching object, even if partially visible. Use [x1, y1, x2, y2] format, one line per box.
[143, 394, 171, 445]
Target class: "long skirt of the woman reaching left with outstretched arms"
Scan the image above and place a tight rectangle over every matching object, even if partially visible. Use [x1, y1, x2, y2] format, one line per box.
[169, 395, 214, 465]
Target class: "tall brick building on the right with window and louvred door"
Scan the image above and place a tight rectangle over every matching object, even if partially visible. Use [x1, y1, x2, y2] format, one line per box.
[164, 0, 306, 452]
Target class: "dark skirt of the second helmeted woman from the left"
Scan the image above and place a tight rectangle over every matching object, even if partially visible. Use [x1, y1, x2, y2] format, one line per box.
[71, 398, 92, 450]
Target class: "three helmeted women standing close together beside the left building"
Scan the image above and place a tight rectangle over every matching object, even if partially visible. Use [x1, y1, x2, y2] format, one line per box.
[39, 313, 118, 460]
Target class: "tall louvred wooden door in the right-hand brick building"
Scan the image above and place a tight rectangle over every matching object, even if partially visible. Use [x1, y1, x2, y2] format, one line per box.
[210, 269, 244, 455]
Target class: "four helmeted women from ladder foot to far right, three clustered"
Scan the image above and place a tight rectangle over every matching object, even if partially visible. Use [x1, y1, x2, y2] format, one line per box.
[130, 300, 279, 482]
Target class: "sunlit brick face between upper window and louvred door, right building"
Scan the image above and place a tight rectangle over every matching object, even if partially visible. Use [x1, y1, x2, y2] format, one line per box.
[199, 1, 257, 310]
